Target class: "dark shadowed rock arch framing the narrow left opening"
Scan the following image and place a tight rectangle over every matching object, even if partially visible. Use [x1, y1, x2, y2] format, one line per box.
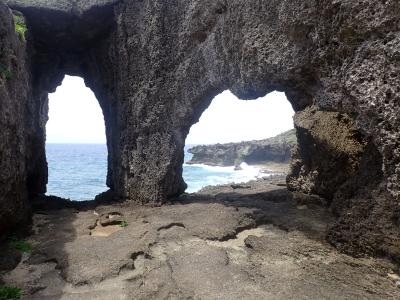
[2, 1, 119, 196]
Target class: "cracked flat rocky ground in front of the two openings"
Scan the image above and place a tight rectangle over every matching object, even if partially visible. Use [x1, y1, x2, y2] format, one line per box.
[0, 178, 400, 300]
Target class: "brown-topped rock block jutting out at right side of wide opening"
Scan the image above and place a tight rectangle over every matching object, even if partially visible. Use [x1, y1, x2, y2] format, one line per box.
[287, 107, 367, 198]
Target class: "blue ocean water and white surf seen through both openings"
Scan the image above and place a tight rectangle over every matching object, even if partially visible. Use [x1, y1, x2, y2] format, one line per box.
[46, 144, 260, 201]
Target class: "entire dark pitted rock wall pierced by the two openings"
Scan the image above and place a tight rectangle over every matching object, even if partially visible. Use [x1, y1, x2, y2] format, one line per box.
[1, 0, 400, 257]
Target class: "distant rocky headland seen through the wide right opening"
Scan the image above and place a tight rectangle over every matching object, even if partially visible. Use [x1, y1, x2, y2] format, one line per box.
[187, 130, 296, 166]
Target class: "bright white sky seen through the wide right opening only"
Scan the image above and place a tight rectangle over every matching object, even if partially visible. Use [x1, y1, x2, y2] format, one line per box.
[186, 91, 294, 144]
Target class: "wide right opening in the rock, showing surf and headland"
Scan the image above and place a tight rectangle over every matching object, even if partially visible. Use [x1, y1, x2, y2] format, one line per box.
[183, 90, 297, 193]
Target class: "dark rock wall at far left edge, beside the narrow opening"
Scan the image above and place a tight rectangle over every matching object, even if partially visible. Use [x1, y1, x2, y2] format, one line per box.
[0, 2, 33, 236]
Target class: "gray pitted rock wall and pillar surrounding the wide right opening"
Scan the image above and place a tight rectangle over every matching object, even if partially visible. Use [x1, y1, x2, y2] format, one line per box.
[104, 1, 399, 205]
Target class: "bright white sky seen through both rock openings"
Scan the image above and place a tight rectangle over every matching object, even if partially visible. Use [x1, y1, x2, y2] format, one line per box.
[46, 76, 294, 144]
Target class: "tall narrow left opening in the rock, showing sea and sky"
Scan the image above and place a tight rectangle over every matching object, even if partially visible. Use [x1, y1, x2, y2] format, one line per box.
[46, 76, 107, 201]
